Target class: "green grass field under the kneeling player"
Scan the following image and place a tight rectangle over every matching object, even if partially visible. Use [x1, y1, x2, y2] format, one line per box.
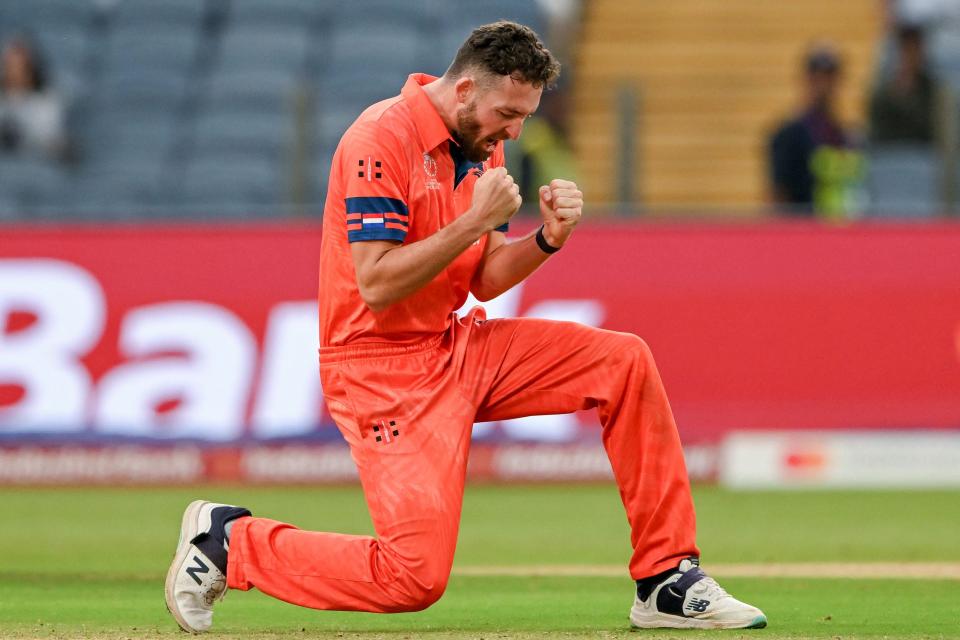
[0, 485, 960, 640]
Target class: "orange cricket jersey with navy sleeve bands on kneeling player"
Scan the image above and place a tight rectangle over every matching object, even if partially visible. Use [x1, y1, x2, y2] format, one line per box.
[319, 74, 506, 347]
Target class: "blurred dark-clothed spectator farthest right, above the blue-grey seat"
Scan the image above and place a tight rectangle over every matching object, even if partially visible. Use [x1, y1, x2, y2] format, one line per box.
[870, 26, 936, 142]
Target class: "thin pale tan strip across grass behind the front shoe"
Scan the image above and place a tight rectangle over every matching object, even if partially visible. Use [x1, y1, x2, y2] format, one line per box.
[453, 562, 960, 580]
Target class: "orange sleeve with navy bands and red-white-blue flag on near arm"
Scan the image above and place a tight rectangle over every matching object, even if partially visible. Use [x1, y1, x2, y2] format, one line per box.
[341, 125, 410, 242]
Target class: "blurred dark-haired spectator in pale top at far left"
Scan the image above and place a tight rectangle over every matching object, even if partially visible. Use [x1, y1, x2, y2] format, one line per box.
[0, 36, 67, 160]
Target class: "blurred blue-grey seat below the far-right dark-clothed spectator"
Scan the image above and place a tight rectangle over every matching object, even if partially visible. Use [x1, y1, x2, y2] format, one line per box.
[868, 145, 943, 218]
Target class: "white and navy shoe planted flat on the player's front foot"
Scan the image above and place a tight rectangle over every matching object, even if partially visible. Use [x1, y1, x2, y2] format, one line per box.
[630, 558, 767, 629]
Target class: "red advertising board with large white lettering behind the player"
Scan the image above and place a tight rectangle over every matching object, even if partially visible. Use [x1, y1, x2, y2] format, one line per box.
[0, 220, 960, 482]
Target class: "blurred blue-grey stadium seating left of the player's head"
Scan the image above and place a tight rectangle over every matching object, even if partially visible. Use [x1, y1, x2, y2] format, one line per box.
[0, 0, 556, 219]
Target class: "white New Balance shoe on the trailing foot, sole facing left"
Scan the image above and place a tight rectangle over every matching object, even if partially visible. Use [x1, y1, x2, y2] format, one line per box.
[164, 500, 250, 633]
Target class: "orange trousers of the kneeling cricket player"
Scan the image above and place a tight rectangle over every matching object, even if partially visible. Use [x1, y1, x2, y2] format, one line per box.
[227, 309, 699, 612]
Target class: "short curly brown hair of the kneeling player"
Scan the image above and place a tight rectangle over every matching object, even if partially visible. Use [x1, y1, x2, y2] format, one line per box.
[444, 20, 560, 89]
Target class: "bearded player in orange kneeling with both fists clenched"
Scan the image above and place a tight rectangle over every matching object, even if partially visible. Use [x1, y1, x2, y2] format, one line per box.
[166, 22, 766, 631]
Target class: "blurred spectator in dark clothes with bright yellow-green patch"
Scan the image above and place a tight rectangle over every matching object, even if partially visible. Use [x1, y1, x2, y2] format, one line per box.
[769, 44, 863, 218]
